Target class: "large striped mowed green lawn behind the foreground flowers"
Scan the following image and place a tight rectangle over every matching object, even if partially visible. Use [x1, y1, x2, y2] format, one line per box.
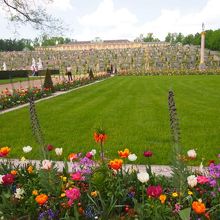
[0, 75, 220, 164]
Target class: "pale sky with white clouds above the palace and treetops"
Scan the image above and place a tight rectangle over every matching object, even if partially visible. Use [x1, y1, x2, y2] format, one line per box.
[0, 0, 220, 41]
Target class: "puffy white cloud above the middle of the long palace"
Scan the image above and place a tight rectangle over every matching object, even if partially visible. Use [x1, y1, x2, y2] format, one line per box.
[77, 0, 137, 39]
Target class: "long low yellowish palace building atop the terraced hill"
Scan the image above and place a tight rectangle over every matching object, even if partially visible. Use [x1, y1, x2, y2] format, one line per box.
[35, 40, 170, 51]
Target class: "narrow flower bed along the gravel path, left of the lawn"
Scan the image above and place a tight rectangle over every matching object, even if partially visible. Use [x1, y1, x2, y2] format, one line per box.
[0, 74, 107, 111]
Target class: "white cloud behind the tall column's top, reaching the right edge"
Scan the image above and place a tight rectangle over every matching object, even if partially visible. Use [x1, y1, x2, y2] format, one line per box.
[136, 0, 220, 39]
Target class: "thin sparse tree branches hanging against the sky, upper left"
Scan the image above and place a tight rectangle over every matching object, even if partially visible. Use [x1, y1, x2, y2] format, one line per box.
[0, 0, 63, 33]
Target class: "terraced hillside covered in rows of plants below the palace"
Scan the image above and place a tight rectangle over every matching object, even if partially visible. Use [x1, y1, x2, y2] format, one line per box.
[0, 44, 220, 74]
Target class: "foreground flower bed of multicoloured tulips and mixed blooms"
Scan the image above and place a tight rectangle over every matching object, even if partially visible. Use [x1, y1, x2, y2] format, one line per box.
[0, 140, 220, 220]
